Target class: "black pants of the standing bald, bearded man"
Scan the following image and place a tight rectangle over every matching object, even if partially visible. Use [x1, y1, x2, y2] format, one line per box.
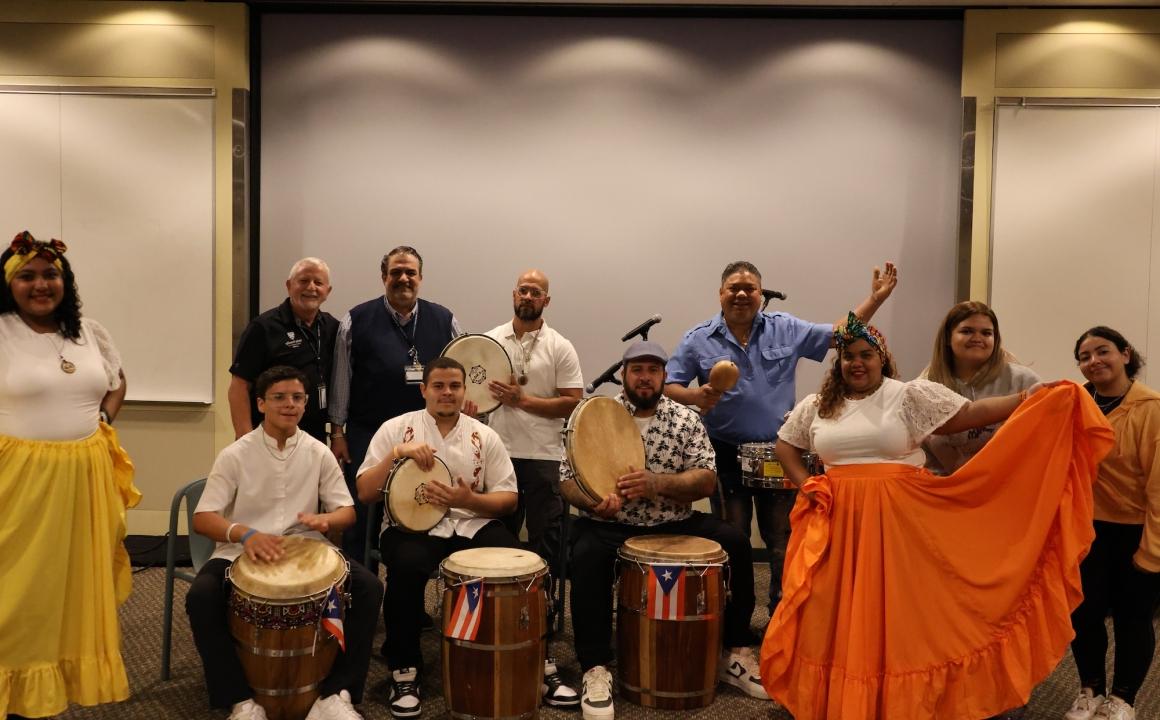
[503, 458, 564, 577]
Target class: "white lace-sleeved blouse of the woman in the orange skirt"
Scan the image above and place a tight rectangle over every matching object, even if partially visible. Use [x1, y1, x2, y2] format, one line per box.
[777, 378, 967, 467]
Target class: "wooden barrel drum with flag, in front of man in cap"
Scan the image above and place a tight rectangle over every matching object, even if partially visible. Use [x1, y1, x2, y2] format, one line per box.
[616, 534, 728, 710]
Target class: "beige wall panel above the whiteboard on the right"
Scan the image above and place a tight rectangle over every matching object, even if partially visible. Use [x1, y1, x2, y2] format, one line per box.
[995, 32, 1160, 88]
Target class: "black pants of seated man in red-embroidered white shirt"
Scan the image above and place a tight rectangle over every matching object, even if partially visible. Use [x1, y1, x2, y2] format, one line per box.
[379, 521, 520, 670]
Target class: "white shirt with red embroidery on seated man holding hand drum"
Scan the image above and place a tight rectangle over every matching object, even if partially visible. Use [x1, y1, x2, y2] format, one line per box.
[358, 409, 519, 538]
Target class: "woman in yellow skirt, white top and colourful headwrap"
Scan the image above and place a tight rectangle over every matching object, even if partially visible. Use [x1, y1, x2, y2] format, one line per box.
[0, 232, 140, 718]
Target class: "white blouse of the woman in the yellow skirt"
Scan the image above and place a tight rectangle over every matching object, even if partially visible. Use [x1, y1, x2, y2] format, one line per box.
[0, 313, 121, 441]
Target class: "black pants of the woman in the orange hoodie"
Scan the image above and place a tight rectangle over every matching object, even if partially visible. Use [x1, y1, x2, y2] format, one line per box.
[1072, 521, 1160, 705]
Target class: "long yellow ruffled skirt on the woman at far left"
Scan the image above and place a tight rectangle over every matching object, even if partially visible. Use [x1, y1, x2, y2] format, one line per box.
[0, 423, 140, 718]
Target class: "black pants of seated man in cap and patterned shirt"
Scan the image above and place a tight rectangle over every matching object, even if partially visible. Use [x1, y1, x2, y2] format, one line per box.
[568, 512, 756, 671]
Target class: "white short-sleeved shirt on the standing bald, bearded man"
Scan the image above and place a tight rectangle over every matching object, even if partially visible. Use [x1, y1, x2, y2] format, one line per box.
[487, 322, 583, 460]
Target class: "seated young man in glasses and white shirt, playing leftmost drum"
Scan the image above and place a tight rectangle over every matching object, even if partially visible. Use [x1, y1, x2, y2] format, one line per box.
[186, 365, 383, 720]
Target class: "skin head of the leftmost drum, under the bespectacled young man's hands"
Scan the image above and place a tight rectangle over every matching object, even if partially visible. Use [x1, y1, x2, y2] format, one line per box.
[230, 534, 347, 601]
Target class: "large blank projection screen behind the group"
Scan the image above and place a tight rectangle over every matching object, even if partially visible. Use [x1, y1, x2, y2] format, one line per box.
[259, 14, 962, 395]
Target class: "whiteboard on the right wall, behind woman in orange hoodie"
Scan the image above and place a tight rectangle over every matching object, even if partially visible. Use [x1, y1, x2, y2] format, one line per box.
[991, 106, 1160, 381]
